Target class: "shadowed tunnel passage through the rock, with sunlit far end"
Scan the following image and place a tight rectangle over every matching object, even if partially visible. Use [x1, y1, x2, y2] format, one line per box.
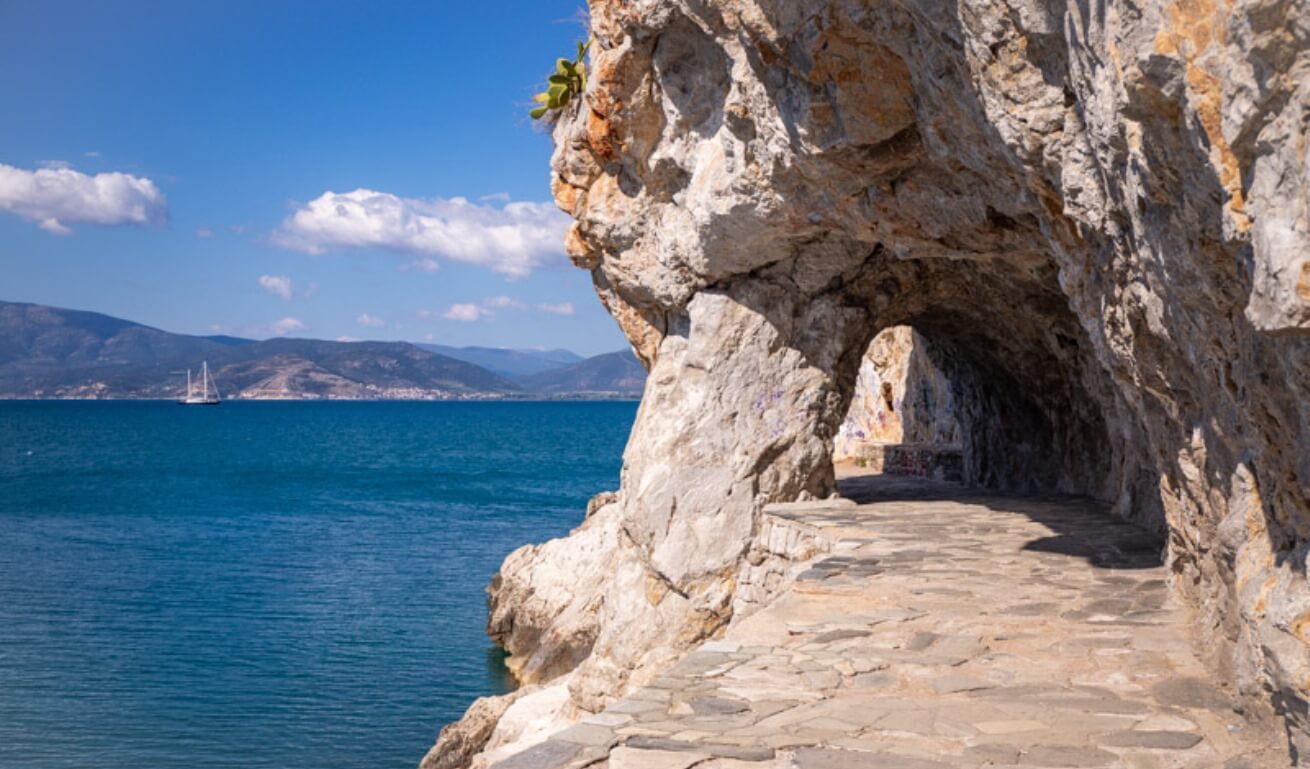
[833, 254, 1165, 542]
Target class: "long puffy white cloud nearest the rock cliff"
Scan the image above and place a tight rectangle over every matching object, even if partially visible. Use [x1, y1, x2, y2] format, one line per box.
[272, 189, 570, 278]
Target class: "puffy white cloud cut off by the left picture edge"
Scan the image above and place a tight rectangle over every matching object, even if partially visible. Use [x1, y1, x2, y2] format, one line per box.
[0, 164, 168, 234]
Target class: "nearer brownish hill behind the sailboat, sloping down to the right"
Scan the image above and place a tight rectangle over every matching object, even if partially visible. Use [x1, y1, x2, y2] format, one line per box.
[0, 303, 524, 398]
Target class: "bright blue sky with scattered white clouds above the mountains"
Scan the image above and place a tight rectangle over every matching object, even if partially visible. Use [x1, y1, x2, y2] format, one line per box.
[0, 0, 634, 354]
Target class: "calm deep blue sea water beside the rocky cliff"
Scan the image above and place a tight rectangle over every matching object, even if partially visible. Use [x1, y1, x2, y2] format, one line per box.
[0, 402, 637, 769]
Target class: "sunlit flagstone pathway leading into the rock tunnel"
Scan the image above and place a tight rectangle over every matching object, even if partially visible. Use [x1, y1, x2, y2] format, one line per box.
[495, 476, 1289, 769]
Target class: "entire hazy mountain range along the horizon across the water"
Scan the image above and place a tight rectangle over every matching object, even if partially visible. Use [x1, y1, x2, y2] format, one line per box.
[0, 301, 646, 400]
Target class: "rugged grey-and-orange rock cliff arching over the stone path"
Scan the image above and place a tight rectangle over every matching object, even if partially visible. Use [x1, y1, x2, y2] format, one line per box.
[424, 0, 1310, 765]
